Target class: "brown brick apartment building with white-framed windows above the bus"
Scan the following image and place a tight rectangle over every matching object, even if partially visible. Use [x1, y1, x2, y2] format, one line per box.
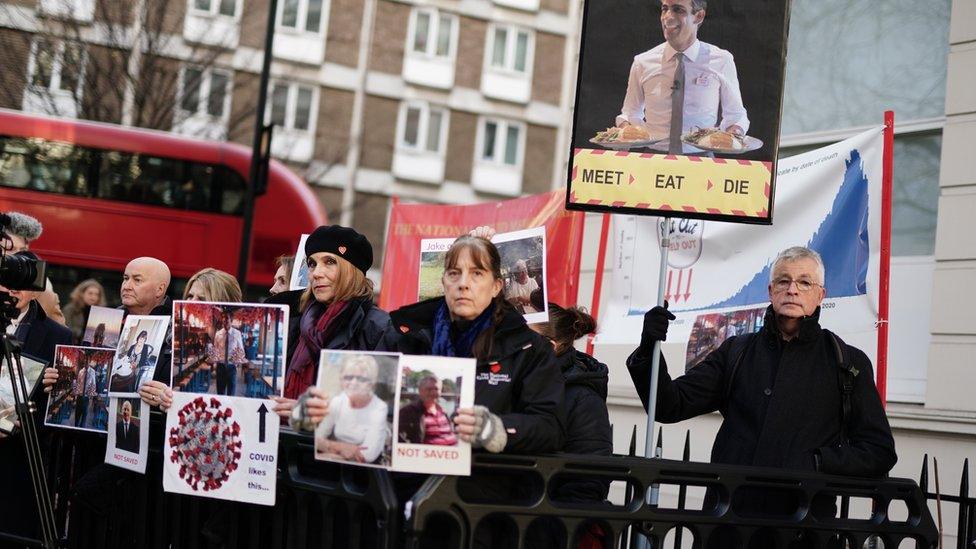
[0, 0, 579, 267]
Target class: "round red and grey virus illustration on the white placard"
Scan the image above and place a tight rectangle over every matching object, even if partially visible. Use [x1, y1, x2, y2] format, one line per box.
[169, 397, 241, 491]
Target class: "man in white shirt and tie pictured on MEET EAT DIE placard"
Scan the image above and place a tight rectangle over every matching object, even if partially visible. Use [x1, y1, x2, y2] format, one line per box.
[616, 0, 749, 154]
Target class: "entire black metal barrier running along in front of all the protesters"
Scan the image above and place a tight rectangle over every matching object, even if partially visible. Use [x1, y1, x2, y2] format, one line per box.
[0, 418, 938, 549]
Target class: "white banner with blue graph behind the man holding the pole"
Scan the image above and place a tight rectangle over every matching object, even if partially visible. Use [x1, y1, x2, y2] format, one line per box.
[596, 127, 884, 384]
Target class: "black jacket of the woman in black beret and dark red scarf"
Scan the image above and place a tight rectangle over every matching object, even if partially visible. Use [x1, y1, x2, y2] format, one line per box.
[265, 290, 390, 364]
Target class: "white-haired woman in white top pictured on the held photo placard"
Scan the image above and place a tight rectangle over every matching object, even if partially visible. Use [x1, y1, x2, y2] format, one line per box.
[315, 355, 390, 463]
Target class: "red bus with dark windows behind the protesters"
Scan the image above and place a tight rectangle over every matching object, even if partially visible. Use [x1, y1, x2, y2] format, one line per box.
[0, 109, 326, 298]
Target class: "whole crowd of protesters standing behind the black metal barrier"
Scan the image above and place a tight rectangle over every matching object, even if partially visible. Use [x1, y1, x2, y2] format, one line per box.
[0, 209, 895, 544]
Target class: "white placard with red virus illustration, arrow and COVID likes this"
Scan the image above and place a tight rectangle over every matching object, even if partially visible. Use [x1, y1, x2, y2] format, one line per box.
[163, 392, 279, 505]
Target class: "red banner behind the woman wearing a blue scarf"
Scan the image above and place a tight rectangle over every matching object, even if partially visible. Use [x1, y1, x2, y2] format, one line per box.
[379, 189, 583, 311]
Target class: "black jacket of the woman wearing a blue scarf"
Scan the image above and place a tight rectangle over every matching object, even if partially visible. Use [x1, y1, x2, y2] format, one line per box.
[377, 297, 564, 454]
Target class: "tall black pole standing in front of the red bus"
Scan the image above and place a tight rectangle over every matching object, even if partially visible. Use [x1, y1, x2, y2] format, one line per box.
[237, 0, 278, 293]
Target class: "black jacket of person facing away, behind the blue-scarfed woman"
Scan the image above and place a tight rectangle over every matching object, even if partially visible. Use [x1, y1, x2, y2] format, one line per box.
[556, 349, 613, 501]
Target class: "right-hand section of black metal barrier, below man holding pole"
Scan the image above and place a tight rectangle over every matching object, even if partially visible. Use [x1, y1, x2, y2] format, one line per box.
[405, 455, 938, 548]
